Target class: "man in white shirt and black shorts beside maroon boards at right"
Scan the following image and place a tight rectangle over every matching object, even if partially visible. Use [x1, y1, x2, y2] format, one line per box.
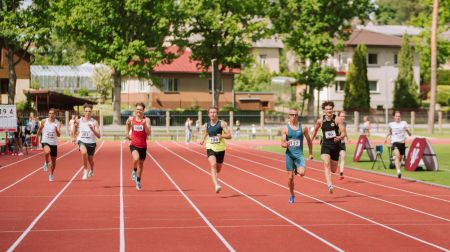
[384, 111, 411, 178]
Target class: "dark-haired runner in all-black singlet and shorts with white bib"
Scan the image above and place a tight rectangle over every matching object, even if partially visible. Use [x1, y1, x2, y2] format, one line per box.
[312, 101, 346, 193]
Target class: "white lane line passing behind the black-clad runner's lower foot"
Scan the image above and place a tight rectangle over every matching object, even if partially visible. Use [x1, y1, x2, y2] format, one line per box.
[221, 148, 450, 222]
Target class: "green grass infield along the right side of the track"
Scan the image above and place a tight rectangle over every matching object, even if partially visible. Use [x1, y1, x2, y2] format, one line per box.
[259, 144, 450, 186]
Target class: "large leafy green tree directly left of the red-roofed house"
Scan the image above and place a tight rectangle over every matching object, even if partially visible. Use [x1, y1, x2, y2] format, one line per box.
[54, 0, 180, 124]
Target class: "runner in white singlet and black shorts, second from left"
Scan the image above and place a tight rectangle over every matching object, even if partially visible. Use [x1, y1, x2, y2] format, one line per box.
[72, 103, 100, 180]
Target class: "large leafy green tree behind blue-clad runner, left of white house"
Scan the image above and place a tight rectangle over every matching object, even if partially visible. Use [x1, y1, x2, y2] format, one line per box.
[270, 0, 374, 115]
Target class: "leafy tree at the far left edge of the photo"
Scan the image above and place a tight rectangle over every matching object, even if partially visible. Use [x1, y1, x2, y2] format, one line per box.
[0, 0, 51, 104]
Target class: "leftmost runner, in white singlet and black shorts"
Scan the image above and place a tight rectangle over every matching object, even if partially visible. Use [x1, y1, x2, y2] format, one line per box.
[37, 108, 61, 182]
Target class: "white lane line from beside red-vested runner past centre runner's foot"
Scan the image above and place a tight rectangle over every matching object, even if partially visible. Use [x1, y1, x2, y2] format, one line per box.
[156, 142, 344, 252]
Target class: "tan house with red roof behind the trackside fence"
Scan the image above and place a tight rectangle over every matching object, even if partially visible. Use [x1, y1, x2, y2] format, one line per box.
[121, 47, 273, 110]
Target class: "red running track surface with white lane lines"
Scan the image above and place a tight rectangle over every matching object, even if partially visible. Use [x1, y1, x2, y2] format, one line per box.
[0, 142, 450, 251]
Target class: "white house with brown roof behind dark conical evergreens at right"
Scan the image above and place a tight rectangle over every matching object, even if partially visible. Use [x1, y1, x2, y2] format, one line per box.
[316, 29, 420, 110]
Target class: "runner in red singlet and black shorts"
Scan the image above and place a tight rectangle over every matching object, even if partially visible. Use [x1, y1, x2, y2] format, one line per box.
[126, 103, 151, 190]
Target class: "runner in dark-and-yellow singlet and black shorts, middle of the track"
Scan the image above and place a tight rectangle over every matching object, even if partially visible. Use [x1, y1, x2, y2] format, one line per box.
[200, 107, 231, 193]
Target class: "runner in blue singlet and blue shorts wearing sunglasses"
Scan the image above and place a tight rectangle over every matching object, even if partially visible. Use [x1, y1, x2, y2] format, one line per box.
[281, 108, 313, 204]
